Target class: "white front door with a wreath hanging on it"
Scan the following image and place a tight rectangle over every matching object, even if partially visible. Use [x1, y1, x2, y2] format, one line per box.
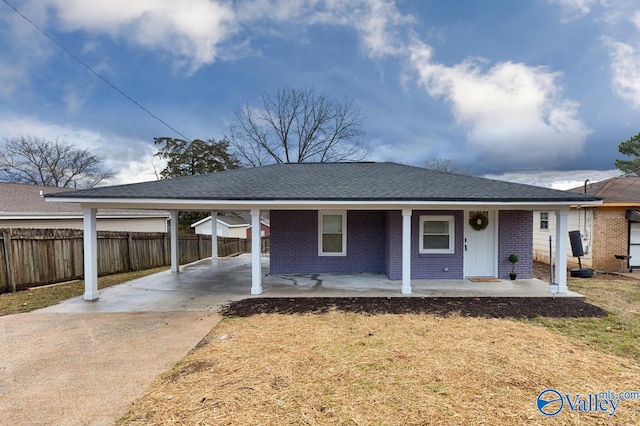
[464, 210, 498, 277]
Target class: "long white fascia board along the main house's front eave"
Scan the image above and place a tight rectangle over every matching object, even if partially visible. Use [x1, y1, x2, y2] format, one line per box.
[47, 197, 602, 211]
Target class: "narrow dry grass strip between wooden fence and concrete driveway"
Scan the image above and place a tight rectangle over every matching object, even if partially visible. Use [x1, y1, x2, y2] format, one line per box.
[0, 267, 168, 316]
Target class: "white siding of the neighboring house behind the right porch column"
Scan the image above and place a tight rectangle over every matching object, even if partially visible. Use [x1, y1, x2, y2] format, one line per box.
[533, 209, 593, 268]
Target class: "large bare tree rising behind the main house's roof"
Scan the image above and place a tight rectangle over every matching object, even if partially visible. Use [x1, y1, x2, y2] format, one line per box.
[227, 88, 367, 166]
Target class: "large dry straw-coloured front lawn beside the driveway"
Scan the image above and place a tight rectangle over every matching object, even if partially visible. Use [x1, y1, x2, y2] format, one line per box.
[123, 312, 640, 425]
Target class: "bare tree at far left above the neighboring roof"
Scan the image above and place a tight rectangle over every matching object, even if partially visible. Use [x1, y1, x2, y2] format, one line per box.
[0, 136, 115, 188]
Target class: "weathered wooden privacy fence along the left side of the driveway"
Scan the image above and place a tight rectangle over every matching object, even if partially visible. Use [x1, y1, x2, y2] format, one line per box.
[0, 229, 269, 293]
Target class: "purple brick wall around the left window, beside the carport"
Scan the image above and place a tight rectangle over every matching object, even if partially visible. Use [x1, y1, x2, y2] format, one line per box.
[270, 210, 386, 274]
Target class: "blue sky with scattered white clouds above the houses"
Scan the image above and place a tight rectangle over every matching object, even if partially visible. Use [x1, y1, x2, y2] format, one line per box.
[0, 0, 640, 187]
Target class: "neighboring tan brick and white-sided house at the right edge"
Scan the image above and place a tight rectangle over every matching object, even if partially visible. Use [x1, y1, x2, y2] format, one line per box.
[533, 176, 640, 271]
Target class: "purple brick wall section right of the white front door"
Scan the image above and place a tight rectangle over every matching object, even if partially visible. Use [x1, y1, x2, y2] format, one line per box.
[498, 210, 533, 279]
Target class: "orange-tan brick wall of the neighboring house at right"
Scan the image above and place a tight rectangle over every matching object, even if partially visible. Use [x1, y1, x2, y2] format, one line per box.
[592, 206, 633, 271]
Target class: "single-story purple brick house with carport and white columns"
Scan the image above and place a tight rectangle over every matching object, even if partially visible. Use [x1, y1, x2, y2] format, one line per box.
[47, 163, 602, 300]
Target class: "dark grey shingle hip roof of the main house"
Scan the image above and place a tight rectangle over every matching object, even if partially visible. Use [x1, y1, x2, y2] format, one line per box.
[47, 163, 599, 202]
